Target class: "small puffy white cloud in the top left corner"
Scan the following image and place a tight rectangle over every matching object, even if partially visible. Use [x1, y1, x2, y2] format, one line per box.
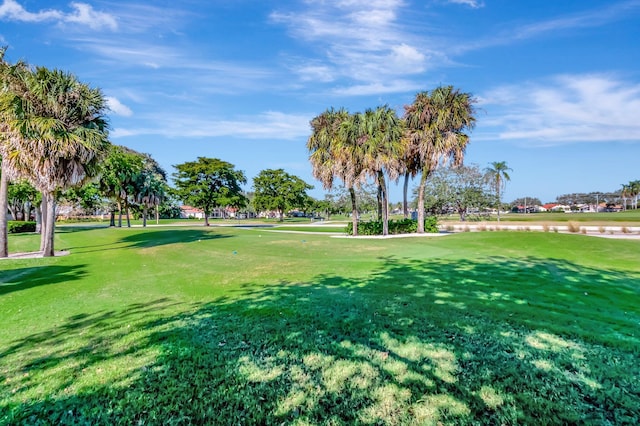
[0, 0, 118, 30]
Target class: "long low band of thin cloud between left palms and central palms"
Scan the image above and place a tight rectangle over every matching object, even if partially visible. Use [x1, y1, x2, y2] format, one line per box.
[111, 111, 312, 140]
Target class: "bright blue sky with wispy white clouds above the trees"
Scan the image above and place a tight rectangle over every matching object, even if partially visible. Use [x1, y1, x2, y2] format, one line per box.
[0, 0, 640, 202]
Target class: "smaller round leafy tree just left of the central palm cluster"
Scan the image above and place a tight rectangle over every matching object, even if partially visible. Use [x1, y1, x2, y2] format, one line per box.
[253, 169, 313, 222]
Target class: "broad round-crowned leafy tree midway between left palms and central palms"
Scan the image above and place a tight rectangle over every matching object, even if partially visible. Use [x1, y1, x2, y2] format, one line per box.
[173, 157, 247, 226]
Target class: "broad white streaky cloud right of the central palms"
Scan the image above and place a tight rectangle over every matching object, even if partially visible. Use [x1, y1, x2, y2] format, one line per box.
[480, 74, 640, 146]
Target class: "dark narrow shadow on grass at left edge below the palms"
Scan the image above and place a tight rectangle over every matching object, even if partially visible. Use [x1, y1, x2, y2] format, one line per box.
[0, 265, 86, 296]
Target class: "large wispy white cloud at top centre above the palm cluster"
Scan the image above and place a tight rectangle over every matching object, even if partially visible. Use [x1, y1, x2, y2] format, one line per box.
[264, 0, 439, 93]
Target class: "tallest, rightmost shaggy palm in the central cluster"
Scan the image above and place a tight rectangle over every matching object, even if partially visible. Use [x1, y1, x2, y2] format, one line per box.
[404, 86, 475, 233]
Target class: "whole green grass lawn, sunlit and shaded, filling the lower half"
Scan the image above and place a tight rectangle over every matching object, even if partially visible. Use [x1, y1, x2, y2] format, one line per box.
[0, 227, 640, 425]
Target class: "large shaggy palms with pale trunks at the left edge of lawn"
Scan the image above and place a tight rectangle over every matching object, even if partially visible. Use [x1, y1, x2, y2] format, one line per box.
[0, 49, 110, 257]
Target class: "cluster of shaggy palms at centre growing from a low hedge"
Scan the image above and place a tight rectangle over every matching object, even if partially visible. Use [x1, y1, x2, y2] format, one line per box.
[307, 86, 475, 235]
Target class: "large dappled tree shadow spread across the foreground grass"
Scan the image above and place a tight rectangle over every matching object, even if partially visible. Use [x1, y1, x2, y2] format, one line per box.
[0, 257, 640, 424]
